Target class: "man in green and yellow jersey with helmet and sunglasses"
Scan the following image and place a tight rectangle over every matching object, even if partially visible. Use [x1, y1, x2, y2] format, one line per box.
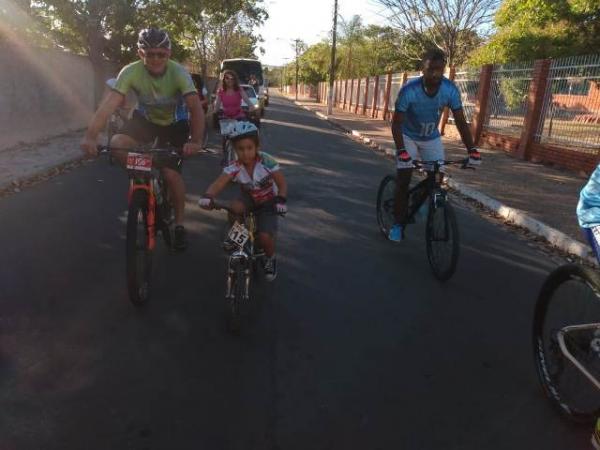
[81, 28, 204, 250]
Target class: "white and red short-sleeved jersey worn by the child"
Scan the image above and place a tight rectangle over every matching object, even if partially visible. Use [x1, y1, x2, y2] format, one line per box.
[223, 152, 279, 203]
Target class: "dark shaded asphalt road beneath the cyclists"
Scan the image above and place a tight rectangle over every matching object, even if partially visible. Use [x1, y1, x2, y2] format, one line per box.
[0, 93, 590, 450]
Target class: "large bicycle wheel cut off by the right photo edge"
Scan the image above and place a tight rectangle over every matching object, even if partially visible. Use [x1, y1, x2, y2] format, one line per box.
[533, 264, 600, 423]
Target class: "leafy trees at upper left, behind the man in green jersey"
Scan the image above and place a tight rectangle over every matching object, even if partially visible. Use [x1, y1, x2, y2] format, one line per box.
[0, 0, 267, 102]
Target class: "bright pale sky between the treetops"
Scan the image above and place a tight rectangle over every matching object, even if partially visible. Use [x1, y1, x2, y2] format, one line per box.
[257, 0, 388, 65]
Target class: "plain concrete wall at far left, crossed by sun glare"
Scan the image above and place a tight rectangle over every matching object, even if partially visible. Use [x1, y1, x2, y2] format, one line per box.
[0, 46, 94, 150]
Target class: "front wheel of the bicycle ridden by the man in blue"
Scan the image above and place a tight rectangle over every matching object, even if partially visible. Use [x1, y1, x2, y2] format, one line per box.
[425, 200, 460, 281]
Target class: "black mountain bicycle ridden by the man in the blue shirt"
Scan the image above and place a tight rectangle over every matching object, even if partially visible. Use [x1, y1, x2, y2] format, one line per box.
[377, 158, 474, 281]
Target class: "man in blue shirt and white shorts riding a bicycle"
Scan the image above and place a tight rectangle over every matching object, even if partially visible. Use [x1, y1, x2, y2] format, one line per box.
[389, 49, 481, 242]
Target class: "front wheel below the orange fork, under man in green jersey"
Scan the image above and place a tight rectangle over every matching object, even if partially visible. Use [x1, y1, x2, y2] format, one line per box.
[125, 190, 153, 306]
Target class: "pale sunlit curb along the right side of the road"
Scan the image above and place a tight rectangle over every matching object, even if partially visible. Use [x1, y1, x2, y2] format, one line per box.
[294, 101, 598, 266]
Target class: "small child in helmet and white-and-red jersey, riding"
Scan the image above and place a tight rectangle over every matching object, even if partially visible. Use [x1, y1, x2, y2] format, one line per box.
[198, 122, 287, 281]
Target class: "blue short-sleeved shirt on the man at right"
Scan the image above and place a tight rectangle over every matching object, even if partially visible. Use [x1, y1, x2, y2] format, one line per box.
[396, 77, 462, 141]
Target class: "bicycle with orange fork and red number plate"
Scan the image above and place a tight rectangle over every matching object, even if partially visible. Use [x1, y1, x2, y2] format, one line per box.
[98, 146, 182, 306]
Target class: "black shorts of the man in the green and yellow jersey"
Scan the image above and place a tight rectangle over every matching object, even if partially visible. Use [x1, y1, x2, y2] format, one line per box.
[119, 111, 190, 172]
